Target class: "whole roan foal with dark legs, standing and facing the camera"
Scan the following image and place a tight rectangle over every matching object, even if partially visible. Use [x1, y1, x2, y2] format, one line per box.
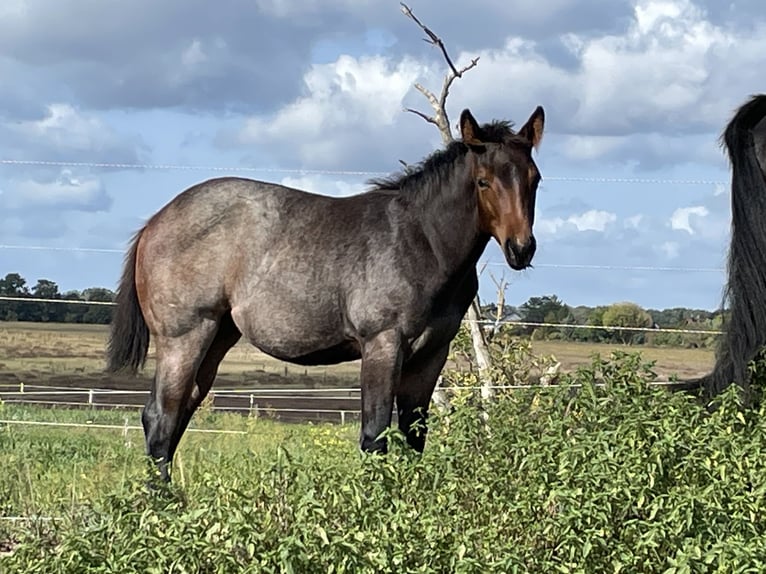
[106, 106, 545, 482]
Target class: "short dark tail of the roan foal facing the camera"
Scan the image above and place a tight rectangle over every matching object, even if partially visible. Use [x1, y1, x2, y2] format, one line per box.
[106, 229, 149, 374]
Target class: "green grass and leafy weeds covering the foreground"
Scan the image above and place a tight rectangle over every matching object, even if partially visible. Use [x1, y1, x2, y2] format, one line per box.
[0, 353, 766, 574]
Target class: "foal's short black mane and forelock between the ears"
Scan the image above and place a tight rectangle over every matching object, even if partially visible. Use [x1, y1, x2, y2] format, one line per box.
[367, 120, 524, 196]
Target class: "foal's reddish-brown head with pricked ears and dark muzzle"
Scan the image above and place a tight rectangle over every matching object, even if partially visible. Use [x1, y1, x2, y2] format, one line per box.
[460, 106, 545, 270]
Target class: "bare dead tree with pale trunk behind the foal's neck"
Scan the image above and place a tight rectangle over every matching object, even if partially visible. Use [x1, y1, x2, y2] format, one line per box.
[401, 2, 494, 399]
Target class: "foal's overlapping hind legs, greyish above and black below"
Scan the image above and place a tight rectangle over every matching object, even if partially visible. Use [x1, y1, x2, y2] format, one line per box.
[141, 319, 218, 481]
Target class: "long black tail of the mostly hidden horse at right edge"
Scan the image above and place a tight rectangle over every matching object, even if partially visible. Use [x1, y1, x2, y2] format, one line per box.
[697, 94, 766, 400]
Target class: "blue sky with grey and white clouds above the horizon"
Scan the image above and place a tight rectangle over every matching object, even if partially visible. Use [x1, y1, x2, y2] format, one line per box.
[0, 0, 766, 316]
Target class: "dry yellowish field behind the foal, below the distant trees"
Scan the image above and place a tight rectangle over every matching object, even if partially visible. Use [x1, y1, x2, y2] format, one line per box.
[0, 322, 714, 388]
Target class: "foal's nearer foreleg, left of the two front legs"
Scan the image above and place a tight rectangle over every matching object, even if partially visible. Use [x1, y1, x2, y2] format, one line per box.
[359, 331, 402, 453]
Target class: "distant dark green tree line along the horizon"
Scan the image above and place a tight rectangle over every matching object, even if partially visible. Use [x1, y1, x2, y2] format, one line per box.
[0, 273, 723, 347]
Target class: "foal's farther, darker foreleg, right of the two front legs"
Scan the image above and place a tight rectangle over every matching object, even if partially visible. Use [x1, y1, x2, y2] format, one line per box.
[396, 345, 449, 452]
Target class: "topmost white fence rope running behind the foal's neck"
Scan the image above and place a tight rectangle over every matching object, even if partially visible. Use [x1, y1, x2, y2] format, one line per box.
[0, 158, 728, 185]
